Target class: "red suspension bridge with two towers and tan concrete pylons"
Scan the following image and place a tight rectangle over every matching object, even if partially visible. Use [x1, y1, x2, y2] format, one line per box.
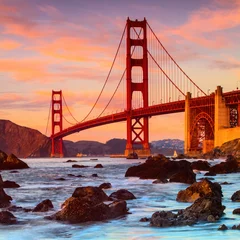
[47, 18, 240, 156]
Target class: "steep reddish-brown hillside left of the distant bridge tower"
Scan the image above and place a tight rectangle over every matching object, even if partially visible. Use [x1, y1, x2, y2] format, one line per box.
[0, 120, 51, 157]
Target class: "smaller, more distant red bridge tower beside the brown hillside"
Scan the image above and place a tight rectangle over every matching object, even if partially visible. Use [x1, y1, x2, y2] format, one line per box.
[51, 91, 63, 157]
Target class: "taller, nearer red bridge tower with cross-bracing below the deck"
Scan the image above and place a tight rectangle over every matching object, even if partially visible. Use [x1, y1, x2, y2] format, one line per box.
[125, 18, 150, 156]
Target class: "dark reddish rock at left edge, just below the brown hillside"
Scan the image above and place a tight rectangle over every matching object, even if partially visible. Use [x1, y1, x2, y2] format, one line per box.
[0, 154, 29, 170]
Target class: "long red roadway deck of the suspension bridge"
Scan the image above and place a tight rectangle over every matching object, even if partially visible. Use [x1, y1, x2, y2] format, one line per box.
[51, 90, 240, 139]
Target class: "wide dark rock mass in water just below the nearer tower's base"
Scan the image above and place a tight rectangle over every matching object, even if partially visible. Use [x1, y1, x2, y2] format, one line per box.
[125, 156, 196, 184]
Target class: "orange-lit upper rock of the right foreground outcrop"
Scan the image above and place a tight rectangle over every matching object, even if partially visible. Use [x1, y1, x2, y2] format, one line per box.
[176, 179, 222, 202]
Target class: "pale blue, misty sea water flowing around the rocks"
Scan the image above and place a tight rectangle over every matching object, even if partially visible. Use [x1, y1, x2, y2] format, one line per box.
[0, 158, 240, 240]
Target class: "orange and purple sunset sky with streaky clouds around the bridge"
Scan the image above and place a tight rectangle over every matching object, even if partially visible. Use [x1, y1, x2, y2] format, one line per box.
[0, 0, 240, 142]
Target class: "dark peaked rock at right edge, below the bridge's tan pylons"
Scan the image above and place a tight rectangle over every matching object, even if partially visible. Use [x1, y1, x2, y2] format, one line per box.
[209, 155, 238, 174]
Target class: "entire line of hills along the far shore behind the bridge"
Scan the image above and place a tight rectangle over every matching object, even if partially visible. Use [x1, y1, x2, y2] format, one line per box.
[0, 120, 183, 158]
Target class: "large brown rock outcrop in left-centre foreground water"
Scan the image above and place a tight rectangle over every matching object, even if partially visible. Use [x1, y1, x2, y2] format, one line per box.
[47, 187, 128, 223]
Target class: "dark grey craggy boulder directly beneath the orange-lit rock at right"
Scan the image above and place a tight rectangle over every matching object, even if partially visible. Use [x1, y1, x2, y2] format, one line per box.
[183, 196, 225, 221]
